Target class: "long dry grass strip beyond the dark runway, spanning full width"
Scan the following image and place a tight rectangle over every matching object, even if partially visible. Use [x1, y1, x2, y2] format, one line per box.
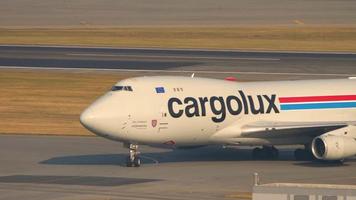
[0, 25, 356, 52]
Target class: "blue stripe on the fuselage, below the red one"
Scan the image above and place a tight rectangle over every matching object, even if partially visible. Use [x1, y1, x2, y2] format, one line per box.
[280, 102, 356, 110]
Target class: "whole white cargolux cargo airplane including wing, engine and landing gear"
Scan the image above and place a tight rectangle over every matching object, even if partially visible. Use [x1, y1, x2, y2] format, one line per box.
[80, 76, 356, 167]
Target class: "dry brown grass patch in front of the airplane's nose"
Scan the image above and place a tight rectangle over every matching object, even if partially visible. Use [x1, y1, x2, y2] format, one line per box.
[0, 70, 133, 135]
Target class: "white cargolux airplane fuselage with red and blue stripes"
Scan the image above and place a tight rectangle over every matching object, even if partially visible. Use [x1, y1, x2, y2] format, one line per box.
[81, 76, 356, 146]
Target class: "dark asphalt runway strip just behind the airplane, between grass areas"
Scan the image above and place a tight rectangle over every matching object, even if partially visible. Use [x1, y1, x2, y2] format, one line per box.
[0, 46, 356, 80]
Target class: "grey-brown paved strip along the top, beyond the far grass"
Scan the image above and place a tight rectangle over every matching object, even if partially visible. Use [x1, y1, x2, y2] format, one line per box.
[0, 0, 356, 28]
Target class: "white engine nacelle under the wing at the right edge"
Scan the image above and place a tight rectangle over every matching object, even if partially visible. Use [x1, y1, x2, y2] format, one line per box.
[311, 134, 356, 160]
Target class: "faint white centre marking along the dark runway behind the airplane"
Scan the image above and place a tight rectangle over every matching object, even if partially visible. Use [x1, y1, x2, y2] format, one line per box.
[65, 53, 281, 61]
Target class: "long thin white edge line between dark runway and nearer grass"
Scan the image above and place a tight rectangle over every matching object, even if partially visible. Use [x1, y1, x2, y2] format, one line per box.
[0, 66, 356, 78]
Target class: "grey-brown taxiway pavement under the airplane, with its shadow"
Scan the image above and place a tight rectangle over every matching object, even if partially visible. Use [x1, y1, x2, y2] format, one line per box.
[0, 135, 356, 200]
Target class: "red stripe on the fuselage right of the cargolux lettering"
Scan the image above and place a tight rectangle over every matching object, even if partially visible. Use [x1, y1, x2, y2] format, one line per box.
[279, 95, 356, 103]
